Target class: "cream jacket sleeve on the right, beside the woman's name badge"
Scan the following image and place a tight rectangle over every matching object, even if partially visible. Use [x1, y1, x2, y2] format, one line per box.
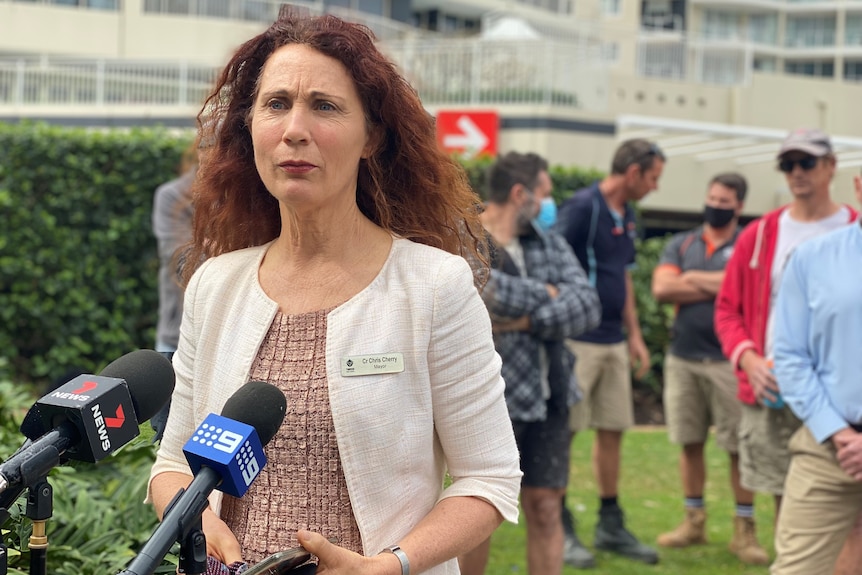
[430, 258, 521, 522]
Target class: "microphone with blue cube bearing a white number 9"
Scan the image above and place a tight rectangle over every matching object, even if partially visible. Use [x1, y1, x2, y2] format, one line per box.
[119, 381, 287, 575]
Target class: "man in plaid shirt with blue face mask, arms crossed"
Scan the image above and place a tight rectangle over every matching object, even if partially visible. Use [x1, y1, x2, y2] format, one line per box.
[459, 152, 600, 575]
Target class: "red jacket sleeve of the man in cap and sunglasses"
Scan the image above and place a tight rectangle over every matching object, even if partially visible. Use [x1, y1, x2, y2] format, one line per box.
[715, 222, 758, 366]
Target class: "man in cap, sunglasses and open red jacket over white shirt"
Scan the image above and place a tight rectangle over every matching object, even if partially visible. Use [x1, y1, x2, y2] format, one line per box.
[715, 129, 857, 560]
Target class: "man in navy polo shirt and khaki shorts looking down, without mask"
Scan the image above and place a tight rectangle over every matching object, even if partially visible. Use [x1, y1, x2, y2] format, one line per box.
[556, 139, 665, 568]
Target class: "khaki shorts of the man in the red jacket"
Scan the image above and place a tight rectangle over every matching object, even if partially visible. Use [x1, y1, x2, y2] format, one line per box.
[739, 404, 802, 495]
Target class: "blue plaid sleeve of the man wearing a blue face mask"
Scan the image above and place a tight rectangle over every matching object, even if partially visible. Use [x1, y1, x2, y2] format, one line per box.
[530, 233, 602, 340]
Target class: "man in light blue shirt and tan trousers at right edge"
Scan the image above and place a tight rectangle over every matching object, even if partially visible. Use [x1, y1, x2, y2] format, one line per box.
[770, 205, 862, 575]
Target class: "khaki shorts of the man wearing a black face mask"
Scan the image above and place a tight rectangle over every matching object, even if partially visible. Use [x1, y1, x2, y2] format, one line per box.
[664, 353, 741, 453]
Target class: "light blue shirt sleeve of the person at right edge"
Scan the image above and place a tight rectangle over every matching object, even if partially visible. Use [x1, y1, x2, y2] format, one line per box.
[774, 250, 847, 442]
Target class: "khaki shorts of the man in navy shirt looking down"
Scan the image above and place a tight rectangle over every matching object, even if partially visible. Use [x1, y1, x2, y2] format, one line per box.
[566, 339, 635, 431]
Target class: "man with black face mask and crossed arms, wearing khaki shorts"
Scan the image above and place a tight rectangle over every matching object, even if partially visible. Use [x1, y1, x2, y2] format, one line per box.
[652, 173, 769, 565]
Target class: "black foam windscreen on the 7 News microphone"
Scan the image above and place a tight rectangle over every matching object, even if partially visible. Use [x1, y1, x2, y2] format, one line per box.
[99, 349, 176, 423]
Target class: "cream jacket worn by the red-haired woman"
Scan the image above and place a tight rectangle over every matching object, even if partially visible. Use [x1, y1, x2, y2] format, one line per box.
[150, 239, 521, 575]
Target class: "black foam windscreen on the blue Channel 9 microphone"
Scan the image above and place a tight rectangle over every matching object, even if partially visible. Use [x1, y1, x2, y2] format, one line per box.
[221, 381, 287, 445]
